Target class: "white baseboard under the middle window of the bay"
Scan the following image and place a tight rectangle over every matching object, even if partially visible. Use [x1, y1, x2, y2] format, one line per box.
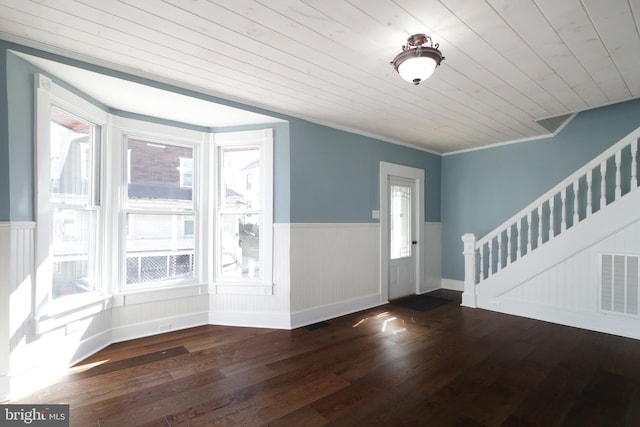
[111, 311, 209, 343]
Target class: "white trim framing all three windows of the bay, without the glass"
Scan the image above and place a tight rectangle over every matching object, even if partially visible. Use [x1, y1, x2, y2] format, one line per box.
[33, 74, 273, 310]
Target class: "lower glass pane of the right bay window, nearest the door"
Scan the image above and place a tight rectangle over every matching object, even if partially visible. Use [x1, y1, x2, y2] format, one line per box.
[219, 214, 260, 279]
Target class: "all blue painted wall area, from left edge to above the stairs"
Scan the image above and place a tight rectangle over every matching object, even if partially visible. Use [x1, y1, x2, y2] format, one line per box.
[5, 41, 640, 280]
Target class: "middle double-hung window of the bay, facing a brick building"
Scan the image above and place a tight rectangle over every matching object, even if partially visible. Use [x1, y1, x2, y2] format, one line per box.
[122, 132, 199, 290]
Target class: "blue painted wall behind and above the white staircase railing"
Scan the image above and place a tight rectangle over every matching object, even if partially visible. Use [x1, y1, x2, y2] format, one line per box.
[442, 100, 640, 280]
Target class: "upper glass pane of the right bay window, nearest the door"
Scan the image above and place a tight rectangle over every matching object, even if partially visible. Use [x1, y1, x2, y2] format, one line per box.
[221, 147, 262, 210]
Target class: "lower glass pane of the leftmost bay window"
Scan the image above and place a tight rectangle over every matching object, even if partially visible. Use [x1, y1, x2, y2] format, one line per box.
[52, 209, 97, 299]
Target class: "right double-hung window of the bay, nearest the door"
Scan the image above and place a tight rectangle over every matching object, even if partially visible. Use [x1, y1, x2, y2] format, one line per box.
[214, 129, 273, 293]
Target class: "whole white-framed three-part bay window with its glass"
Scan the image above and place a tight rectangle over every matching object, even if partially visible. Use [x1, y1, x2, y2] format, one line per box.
[35, 75, 273, 311]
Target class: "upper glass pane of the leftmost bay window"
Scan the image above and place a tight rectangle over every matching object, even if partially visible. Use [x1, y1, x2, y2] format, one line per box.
[49, 107, 97, 205]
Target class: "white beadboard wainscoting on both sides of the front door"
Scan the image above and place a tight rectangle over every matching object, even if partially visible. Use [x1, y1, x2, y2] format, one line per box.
[290, 222, 442, 328]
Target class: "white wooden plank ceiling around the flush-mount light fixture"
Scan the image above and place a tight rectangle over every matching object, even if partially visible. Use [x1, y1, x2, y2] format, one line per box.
[0, 0, 640, 153]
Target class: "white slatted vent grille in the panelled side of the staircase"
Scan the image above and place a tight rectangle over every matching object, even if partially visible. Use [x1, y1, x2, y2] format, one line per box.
[600, 254, 640, 317]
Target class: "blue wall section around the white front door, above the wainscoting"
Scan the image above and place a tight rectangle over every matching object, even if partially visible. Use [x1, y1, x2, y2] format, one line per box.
[290, 119, 441, 223]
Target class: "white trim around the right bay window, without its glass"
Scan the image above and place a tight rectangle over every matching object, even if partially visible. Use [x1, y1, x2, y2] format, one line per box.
[209, 128, 273, 295]
